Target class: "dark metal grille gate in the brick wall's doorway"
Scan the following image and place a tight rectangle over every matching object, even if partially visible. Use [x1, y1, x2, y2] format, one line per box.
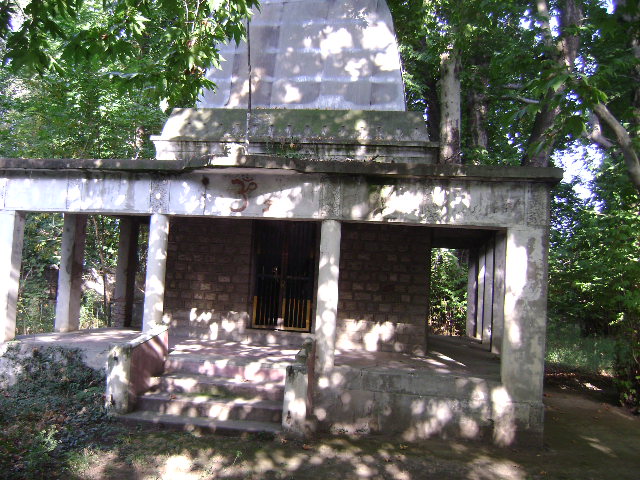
[252, 221, 316, 332]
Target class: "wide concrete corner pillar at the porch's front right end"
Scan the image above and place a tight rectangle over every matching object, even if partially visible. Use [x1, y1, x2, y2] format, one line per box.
[501, 228, 548, 408]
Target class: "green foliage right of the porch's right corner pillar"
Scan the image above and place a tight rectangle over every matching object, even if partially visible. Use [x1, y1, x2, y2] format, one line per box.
[549, 156, 640, 408]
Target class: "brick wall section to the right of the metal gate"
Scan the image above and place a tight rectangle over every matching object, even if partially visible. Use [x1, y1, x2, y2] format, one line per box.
[336, 223, 430, 354]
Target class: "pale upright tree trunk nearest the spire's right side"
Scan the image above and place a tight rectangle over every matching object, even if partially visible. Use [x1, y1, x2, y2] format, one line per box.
[439, 46, 462, 165]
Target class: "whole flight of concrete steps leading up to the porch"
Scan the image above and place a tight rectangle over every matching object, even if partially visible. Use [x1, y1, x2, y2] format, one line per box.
[122, 342, 289, 435]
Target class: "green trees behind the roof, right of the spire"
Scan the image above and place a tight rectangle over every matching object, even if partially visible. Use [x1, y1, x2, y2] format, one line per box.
[390, 0, 640, 191]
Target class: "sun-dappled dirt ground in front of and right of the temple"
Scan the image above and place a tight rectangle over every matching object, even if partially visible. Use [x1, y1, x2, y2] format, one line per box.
[76, 372, 640, 480]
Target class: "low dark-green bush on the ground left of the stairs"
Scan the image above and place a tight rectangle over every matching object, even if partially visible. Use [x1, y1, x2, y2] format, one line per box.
[0, 345, 120, 479]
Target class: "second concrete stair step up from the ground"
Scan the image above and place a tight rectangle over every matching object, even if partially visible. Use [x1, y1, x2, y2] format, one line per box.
[137, 393, 282, 423]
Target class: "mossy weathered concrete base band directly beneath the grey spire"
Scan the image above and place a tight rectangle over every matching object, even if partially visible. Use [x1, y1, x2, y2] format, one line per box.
[151, 108, 438, 165]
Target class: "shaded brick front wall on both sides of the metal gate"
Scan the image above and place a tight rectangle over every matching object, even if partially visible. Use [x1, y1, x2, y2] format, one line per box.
[164, 217, 429, 353]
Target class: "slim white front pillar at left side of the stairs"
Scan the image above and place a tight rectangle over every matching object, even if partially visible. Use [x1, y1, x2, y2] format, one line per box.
[142, 213, 169, 332]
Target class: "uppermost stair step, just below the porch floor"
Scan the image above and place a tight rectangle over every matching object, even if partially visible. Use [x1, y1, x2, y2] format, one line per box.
[165, 355, 289, 382]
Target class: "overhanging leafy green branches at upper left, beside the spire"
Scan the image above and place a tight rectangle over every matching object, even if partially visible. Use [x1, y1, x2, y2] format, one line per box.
[0, 0, 257, 107]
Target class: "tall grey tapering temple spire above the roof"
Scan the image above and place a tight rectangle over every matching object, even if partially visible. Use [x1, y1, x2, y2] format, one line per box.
[198, 0, 406, 111]
